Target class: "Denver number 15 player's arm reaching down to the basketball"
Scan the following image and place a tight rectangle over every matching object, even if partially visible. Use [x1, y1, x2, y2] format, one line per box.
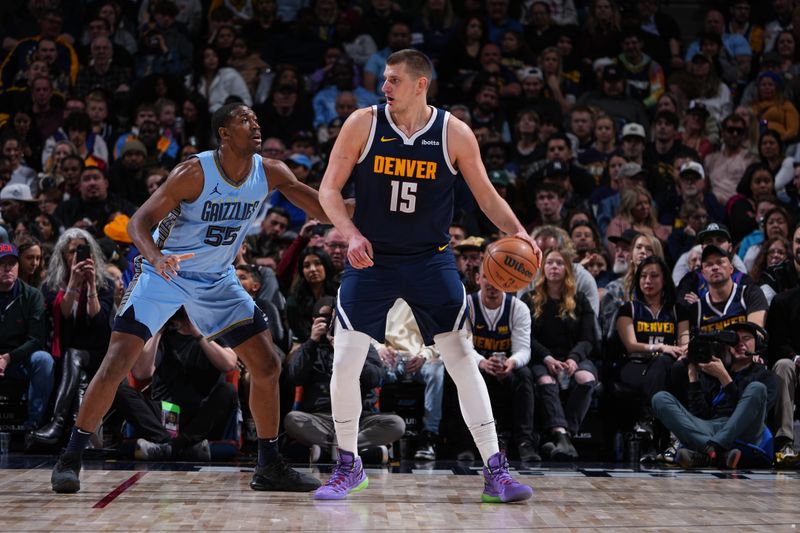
[447, 115, 542, 259]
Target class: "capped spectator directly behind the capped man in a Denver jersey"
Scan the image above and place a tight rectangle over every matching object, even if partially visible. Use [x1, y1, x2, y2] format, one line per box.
[672, 222, 756, 304]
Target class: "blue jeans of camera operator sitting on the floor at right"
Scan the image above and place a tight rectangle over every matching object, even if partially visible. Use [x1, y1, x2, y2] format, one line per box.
[652, 381, 767, 452]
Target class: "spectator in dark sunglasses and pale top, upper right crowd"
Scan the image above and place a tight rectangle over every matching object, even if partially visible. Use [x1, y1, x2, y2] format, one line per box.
[705, 114, 757, 204]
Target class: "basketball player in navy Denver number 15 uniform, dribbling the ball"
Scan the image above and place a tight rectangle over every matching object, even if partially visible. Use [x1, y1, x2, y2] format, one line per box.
[315, 50, 541, 502]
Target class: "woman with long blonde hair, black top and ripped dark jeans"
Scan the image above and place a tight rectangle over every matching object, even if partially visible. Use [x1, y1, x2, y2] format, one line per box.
[530, 248, 597, 461]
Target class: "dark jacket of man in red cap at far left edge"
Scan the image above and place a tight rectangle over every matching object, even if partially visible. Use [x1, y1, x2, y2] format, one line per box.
[0, 279, 47, 363]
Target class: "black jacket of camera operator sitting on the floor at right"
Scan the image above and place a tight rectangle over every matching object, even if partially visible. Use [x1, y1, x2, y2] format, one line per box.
[689, 363, 778, 420]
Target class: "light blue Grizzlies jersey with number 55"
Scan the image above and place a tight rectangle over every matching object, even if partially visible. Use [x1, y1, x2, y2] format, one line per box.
[153, 150, 269, 273]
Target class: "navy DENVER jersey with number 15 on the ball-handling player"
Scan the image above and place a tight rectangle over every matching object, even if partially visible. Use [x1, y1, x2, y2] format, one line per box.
[353, 104, 456, 254]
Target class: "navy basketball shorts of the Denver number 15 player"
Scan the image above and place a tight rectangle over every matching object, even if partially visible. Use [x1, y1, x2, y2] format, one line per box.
[336, 248, 467, 345]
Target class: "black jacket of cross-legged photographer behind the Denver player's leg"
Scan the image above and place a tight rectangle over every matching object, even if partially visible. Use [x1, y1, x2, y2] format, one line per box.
[284, 339, 386, 413]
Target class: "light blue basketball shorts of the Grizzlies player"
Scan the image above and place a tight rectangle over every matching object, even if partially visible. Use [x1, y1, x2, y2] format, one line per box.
[114, 259, 267, 347]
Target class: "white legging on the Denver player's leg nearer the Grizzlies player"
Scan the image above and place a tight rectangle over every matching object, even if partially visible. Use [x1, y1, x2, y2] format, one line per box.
[331, 328, 369, 455]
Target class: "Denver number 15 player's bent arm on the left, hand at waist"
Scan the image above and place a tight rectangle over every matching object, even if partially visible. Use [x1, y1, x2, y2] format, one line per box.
[319, 108, 372, 268]
